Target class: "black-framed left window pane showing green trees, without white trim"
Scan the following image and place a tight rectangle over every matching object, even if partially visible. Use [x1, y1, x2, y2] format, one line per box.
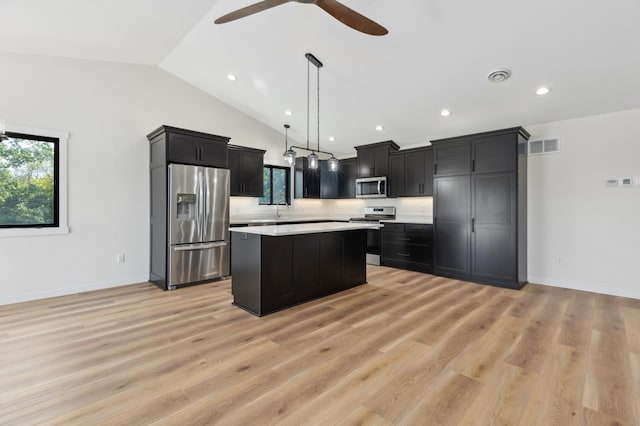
[0, 133, 59, 228]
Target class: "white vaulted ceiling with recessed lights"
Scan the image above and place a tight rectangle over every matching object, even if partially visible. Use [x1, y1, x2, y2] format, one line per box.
[0, 0, 640, 155]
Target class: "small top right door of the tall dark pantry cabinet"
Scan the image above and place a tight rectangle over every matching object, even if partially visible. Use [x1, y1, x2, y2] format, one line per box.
[471, 134, 518, 173]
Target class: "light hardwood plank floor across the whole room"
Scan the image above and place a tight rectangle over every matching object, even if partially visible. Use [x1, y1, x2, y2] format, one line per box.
[0, 266, 640, 425]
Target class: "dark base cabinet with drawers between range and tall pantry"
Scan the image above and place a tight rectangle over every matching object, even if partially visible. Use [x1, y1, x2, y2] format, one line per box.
[380, 223, 433, 273]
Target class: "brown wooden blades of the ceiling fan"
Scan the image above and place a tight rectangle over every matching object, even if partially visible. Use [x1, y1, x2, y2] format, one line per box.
[215, 0, 389, 36]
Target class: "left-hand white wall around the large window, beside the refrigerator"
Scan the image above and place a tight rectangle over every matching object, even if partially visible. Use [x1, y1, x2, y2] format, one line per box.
[0, 54, 283, 304]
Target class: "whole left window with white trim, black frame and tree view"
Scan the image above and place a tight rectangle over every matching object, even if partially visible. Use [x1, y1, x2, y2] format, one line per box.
[0, 126, 68, 236]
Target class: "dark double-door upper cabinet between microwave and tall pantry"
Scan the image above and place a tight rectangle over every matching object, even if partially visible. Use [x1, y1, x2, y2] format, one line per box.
[388, 148, 433, 197]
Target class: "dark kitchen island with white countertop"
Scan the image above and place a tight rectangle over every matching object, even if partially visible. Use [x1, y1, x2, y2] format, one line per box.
[230, 222, 372, 316]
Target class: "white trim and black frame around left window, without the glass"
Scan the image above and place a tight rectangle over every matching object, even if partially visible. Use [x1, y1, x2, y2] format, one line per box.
[0, 124, 69, 237]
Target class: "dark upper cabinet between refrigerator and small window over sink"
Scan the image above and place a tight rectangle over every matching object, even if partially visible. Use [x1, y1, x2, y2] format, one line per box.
[229, 145, 266, 197]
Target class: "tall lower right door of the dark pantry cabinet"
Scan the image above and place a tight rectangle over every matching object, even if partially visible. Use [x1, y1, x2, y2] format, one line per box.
[471, 172, 517, 284]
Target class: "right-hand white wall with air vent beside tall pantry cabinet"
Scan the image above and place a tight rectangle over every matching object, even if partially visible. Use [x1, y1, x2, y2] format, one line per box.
[527, 109, 640, 298]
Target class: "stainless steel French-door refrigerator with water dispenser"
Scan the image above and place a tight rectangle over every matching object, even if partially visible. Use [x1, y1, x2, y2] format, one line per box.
[167, 164, 230, 289]
